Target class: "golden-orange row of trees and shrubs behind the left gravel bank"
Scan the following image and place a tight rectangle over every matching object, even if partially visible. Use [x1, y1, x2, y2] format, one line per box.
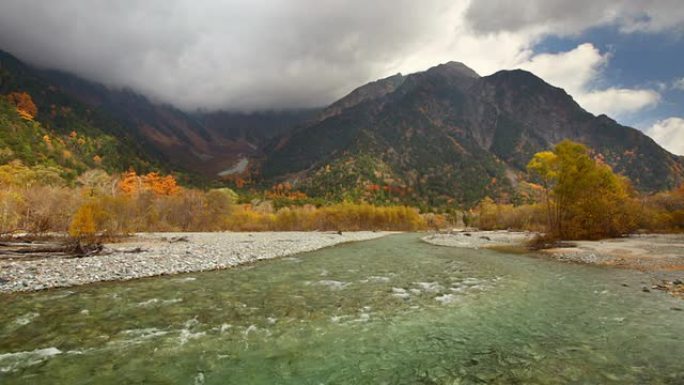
[0, 161, 425, 238]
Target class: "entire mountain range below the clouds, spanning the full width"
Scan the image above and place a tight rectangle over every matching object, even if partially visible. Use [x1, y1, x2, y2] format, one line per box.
[0, 51, 684, 207]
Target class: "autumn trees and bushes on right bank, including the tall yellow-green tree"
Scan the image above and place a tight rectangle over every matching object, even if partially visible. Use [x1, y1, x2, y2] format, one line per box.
[471, 140, 684, 240]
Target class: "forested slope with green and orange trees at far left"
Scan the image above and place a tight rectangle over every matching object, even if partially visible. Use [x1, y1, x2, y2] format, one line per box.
[0, 51, 165, 178]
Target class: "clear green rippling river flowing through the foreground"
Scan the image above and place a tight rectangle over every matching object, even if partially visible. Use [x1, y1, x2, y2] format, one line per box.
[0, 234, 684, 385]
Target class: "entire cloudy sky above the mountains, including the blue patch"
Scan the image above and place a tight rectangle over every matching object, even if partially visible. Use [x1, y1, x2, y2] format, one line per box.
[0, 0, 684, 154]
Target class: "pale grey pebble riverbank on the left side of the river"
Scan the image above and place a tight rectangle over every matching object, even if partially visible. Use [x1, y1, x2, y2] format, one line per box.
[0, 231, 389, 293]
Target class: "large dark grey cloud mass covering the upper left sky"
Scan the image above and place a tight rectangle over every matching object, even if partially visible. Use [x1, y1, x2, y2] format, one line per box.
[0, 0, 451, 108]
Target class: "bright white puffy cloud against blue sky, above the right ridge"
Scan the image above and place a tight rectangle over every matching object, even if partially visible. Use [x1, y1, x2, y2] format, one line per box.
[517, 43, 660, 117]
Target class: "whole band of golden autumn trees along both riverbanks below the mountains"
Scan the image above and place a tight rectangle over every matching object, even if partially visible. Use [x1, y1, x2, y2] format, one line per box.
[0, 128, 684, 239]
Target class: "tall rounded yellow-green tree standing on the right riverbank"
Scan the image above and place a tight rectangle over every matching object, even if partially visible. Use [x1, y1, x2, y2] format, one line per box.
[527, 140, 636, 239]
